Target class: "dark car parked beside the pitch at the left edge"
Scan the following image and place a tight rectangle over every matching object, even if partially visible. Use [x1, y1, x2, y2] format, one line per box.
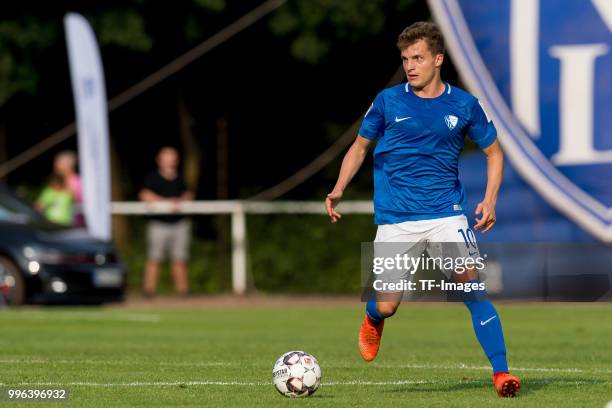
[0, 185, 126, 305]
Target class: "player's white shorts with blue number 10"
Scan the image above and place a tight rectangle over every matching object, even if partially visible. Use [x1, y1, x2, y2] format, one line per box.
[374, 215, 482, 282]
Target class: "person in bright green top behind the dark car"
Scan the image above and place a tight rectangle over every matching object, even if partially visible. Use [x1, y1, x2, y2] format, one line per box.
[36, 174, 74, 225]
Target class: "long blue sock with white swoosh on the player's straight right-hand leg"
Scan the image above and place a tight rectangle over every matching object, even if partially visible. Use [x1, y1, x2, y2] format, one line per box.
[463, 279, 508, 373]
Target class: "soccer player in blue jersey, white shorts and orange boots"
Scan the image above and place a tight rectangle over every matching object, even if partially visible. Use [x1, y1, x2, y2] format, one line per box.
[325, 22, 520, 397]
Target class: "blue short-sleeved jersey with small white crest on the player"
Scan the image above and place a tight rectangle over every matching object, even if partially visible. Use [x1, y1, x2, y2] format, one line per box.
[359, 83, 497, 224]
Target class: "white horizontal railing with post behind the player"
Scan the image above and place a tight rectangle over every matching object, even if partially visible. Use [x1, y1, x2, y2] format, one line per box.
[111, 200, 374, 294]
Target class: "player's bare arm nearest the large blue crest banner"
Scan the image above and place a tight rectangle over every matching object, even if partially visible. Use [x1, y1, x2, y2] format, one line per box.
[474, 140, 504, 233]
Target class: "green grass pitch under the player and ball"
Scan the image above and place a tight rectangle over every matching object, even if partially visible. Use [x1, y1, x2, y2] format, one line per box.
[0, 302, 612, 408]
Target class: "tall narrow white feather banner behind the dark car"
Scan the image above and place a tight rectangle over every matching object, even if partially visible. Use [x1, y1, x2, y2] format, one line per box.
[64, 13, 111, 241]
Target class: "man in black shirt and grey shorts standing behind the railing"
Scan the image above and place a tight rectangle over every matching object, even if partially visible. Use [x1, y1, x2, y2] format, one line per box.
[139, 147, 193, 297]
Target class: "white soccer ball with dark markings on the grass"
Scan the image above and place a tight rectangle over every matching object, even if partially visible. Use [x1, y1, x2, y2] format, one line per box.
[272, 351, 321, 397]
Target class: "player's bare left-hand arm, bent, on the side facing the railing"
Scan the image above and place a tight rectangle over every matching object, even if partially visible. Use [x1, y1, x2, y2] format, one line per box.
[325, 135, 372, 223]
